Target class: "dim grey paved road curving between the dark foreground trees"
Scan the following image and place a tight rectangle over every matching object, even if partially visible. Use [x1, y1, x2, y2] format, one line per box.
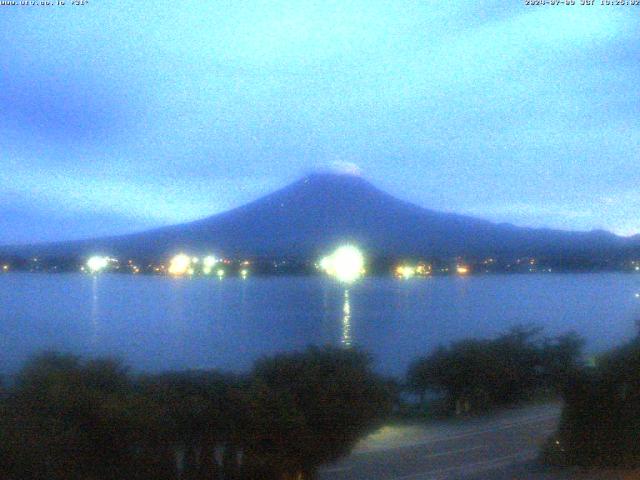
[320, 404, 560, 480]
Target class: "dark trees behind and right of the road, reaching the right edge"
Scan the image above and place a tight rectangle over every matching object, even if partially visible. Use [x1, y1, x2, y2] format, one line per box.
[406, 322, 640, 468]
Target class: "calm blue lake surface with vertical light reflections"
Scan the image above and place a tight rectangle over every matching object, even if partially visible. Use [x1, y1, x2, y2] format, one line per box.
[0, 273, 640, 375]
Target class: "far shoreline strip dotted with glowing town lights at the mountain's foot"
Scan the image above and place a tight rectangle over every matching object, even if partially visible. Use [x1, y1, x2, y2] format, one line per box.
[42, 251, 640, 283]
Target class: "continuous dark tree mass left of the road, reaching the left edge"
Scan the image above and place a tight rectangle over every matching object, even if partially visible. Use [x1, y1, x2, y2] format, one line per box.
[0, 348, 392, 480]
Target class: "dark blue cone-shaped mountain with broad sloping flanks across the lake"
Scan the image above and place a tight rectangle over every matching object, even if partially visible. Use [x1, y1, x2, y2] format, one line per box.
[0, 173, 640, 258]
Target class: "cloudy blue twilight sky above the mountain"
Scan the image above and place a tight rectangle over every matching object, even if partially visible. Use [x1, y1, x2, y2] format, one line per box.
[0, 0, 640, 244]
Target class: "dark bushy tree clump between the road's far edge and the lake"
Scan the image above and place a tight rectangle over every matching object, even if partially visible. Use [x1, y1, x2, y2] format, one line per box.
[406, 327, 584, 414]
